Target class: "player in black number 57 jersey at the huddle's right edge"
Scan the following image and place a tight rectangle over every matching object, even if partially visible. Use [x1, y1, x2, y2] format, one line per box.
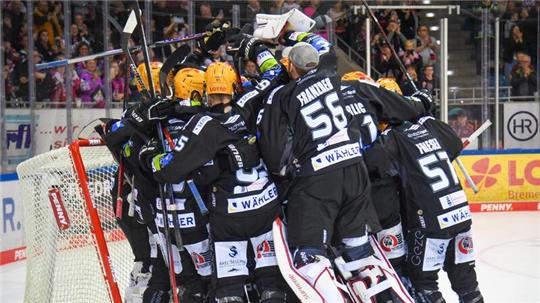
[373, 116, 483, 303]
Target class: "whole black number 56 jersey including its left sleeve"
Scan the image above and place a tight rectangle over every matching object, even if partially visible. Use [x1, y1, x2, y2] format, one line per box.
[258, 69, 361, 175]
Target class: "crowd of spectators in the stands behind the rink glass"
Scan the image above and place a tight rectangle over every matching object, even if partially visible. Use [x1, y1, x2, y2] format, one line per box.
[0, 0, 537, 107]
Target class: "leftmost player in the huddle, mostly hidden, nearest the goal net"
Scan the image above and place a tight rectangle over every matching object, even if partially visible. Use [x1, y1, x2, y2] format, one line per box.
[98, 62, 170, 302]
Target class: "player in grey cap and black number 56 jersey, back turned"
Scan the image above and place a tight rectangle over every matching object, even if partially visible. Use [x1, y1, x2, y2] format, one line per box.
[259, 32, 388, 302]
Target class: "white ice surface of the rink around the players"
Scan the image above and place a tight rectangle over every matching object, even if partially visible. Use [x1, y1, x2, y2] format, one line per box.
[0, 211, 540, 303]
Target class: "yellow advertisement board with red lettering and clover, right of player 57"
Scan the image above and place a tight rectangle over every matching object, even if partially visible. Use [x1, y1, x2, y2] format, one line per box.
[454, 153, 540, 211]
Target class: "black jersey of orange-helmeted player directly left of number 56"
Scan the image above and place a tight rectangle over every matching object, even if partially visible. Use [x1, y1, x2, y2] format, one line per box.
[152, 114, 279, 216]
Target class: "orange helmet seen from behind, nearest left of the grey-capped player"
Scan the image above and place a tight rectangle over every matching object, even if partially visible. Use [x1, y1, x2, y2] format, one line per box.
[204, 62, 237, 95]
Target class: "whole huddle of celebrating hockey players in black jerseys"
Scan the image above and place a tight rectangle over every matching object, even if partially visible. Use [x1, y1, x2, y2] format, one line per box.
[101, 22, 483, 303]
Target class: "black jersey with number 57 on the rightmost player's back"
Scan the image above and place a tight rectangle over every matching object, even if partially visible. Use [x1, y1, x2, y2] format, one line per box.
[374, 117, 471, 235]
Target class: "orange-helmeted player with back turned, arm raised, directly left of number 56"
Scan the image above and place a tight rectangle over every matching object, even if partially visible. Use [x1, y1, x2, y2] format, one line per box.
[141, 45, 292, 302]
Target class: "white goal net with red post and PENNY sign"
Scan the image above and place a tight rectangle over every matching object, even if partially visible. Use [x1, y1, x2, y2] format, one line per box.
[17, 140, 133, 303]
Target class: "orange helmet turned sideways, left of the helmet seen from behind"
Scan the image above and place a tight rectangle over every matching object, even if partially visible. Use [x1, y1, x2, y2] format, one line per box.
[174, 67, 205, 106]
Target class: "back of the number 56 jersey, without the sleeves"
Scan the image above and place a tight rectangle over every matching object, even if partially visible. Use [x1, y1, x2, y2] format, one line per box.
[284, 70, 361, 175]
